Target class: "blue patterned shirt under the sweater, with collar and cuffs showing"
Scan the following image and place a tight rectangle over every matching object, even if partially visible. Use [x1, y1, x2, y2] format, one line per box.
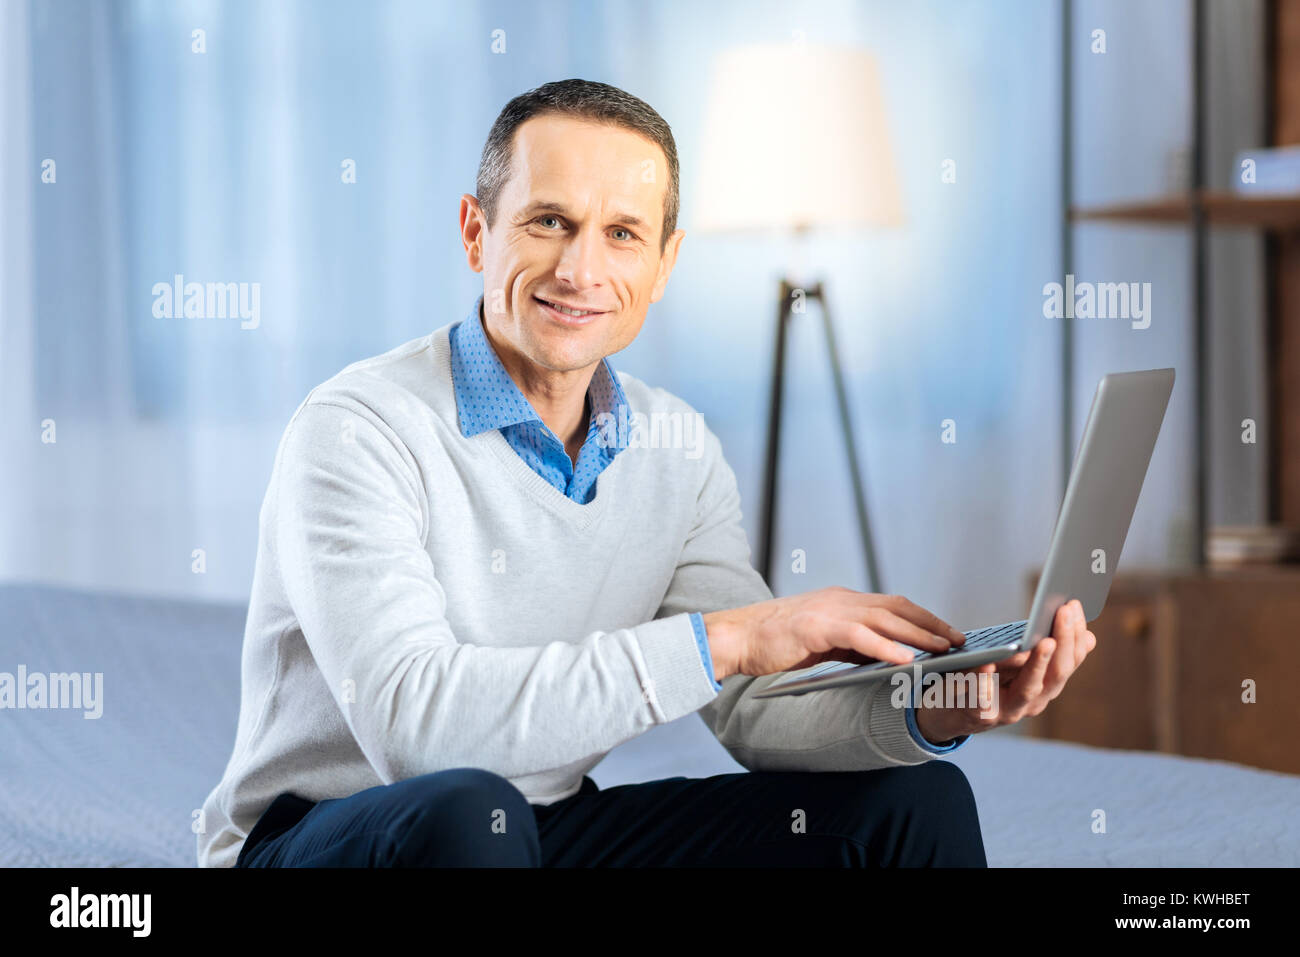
[450, 296, 966, 753]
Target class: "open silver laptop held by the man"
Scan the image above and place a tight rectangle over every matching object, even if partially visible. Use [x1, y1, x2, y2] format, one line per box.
[754, 369, 1174, 698]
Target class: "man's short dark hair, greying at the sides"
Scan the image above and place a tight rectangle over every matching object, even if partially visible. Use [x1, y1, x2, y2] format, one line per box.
[476, 79, 680, 252]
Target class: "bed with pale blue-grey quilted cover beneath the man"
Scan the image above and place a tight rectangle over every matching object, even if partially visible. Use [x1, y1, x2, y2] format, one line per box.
[0, 584, 1300, 867]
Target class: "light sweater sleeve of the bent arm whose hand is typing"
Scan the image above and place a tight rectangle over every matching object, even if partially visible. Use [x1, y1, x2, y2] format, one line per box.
[267, 397, 715, 783]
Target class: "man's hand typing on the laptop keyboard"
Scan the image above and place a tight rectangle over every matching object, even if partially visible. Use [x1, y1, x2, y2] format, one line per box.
[703, 586, 966, 681]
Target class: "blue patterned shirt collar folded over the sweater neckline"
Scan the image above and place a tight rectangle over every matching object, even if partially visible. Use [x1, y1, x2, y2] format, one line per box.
[450, 295, 627, 438]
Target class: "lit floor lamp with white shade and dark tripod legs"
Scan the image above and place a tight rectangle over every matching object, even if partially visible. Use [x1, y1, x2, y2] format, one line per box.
[694, 43, 904, 592]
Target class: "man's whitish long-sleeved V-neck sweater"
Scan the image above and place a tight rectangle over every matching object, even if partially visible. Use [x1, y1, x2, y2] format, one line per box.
[198, 324, 935, 867]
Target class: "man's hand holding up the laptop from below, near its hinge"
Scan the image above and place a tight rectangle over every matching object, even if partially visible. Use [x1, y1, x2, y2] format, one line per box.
[917, 598, 1097, 744]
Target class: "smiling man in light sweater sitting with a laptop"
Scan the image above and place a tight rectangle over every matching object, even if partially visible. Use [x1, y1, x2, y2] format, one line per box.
[198, 79, 1095, 866]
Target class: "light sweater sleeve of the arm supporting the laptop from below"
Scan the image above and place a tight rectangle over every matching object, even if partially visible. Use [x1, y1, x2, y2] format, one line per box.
[659, 418, 937, 771]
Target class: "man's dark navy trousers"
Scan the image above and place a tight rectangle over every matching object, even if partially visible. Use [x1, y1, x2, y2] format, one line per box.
[235, 761, 988, 867]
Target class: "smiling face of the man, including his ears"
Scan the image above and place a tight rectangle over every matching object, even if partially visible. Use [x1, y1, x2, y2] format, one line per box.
[460, 116, 685, 372]
